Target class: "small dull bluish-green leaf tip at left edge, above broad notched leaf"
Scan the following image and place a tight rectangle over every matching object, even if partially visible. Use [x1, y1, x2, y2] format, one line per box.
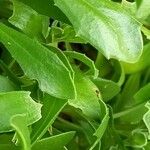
[0, 75, 17, 92]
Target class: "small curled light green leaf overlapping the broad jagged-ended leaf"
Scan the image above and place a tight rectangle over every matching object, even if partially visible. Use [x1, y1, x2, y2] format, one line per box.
[10, 114, 31, 150]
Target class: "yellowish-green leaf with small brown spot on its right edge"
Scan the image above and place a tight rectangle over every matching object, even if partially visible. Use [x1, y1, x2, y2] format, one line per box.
[69, 68, 101, 120]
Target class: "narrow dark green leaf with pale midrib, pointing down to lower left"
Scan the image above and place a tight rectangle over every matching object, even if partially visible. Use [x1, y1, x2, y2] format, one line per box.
[31, 94, 67, 144]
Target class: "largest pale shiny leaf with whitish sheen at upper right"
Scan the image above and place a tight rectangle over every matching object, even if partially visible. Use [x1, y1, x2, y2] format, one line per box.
[54, 0, 143, 63]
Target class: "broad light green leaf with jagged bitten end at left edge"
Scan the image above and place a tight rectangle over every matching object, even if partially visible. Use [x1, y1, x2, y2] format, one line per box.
[0, 91, 41, 133]
